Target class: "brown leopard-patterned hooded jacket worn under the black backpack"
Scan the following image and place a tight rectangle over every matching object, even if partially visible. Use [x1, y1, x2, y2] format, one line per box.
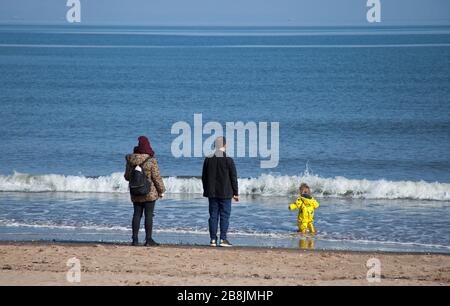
[125, 154, 166, 203]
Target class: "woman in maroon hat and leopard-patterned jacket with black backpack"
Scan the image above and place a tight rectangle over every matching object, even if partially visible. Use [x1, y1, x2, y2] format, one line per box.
[125, 136, 165, 246]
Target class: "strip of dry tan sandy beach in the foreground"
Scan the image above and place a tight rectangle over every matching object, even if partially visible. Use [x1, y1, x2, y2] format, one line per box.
[0, 243, 450, 286]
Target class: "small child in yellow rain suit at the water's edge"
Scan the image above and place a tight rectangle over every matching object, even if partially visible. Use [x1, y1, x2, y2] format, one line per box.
[289, 183, 319, 233]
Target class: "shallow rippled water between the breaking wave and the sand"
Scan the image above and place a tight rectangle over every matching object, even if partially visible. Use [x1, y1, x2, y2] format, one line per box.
[0, 192, 450, 254]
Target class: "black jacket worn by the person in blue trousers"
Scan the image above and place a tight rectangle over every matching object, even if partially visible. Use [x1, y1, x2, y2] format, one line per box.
[202, 154, 239, 199]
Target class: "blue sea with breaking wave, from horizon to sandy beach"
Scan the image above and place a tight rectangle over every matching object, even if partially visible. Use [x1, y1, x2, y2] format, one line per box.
[0, 25, 450, 253]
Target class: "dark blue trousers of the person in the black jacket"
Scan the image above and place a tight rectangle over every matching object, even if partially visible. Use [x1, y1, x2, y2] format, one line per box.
[208, 198, 231, 240]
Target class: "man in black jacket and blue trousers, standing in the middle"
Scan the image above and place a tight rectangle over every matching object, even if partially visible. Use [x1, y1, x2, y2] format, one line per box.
[202, 137, 239, 247]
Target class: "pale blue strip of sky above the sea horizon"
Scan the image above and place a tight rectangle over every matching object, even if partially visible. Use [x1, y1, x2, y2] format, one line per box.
[0, 0, 450, 26]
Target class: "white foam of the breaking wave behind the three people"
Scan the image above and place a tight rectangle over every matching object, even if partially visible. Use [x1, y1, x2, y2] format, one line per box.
[0, 172, 450, 201]
